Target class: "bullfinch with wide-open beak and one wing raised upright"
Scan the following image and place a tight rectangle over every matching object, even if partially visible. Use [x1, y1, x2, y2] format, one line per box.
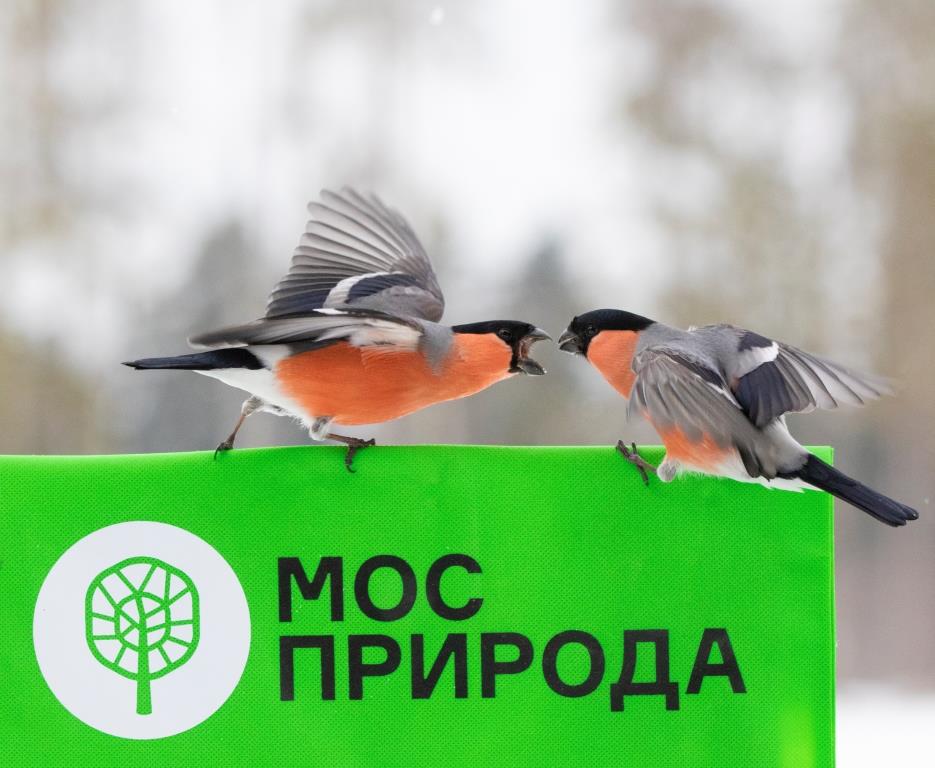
[125, 188, 549, 470]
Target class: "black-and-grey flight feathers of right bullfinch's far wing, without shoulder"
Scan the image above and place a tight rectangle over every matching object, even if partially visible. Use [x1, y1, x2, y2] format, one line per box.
[733, 343, 891, 427]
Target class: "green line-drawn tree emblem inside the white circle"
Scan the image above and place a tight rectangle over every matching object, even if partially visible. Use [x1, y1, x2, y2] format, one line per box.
[85, 557, 199, 715]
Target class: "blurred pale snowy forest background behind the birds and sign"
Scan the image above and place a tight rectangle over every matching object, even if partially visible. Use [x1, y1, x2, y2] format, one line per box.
[0, 0, 935, 768]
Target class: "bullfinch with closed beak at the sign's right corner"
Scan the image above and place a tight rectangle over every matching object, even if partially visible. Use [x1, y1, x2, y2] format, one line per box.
[558, 309, 919, 526]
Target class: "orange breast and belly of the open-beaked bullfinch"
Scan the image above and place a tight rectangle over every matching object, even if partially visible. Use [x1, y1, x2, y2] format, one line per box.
[275, 334, 512, 425]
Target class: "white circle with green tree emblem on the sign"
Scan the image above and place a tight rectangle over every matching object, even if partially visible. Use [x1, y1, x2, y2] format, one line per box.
[33, 522, 250, 739]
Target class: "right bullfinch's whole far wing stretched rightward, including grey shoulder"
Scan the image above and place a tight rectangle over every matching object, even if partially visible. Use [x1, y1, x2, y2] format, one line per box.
[720, 326, 892, 427]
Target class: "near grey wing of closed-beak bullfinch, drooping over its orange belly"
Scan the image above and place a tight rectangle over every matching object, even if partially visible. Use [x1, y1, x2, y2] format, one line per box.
[630, 348, 778, 477]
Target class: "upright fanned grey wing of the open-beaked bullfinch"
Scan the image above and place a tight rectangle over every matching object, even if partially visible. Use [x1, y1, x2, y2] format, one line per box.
[266, 188, 445, 322]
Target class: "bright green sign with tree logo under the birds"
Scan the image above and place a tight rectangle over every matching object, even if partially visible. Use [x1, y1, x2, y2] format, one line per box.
[0, 446, 834, 768]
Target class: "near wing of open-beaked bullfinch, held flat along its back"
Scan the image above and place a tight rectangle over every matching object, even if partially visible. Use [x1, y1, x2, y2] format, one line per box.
[189, 309, 422, 349]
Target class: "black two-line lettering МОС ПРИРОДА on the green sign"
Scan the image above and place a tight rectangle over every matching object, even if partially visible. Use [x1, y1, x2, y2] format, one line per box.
[277, 553, 746, 711]
